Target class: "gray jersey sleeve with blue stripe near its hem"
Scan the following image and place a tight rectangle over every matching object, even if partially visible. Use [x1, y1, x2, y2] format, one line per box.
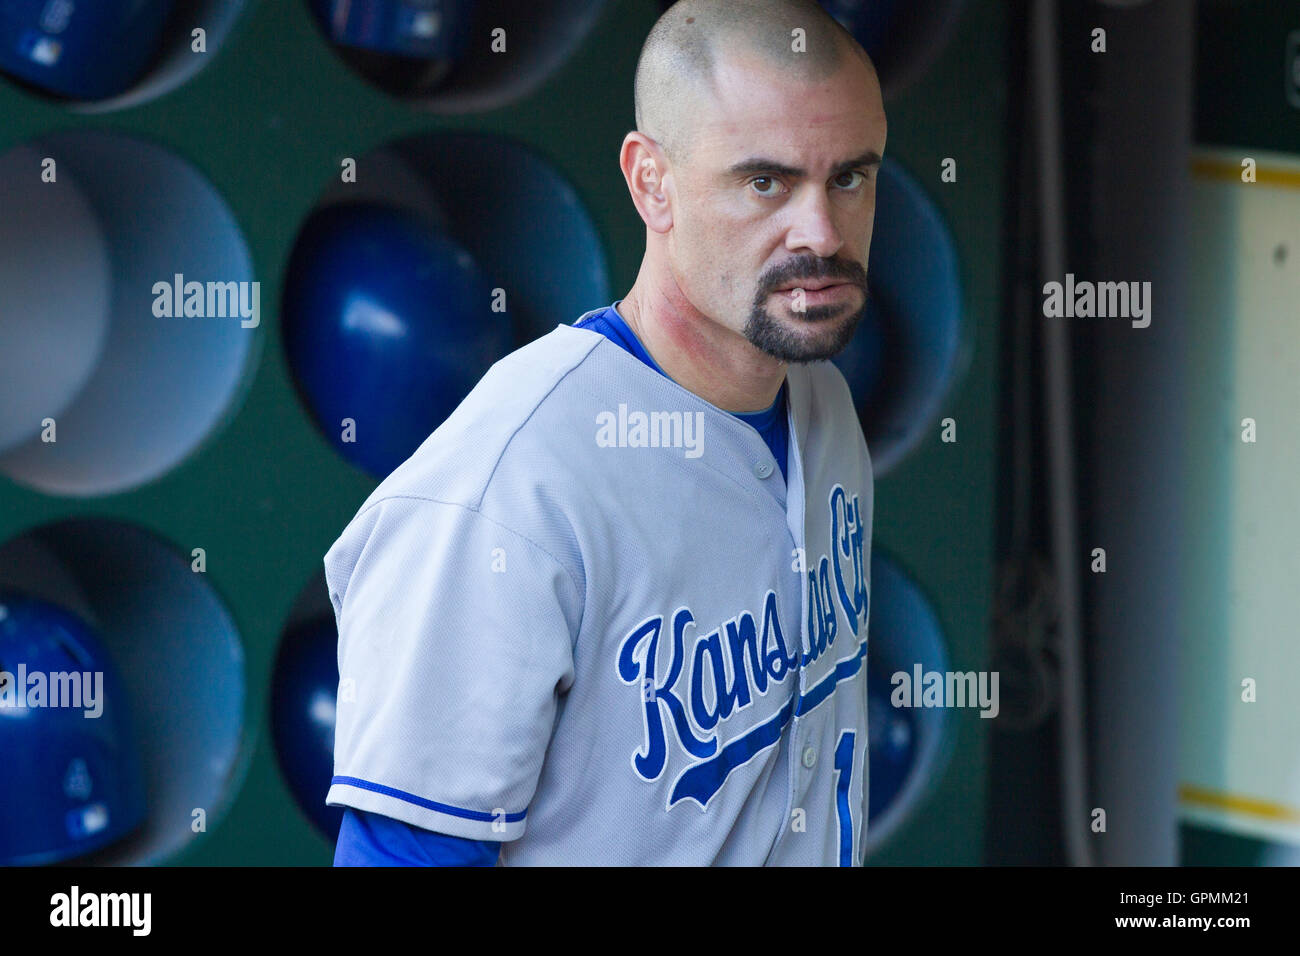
[325, 497, 581, 840]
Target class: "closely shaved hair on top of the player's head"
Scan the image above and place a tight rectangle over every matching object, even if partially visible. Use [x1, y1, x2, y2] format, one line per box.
[633, 0, 875, 163]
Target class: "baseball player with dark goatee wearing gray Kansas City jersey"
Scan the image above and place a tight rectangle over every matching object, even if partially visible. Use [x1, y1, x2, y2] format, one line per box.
[325, 0, 885, 866]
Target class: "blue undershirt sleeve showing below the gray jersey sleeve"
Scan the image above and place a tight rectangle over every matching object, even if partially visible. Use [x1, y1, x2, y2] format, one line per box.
[334, 808, 501, 866]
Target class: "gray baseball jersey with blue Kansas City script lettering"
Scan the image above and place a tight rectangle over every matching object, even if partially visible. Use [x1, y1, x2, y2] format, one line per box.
[325, 316, 872, 866]
